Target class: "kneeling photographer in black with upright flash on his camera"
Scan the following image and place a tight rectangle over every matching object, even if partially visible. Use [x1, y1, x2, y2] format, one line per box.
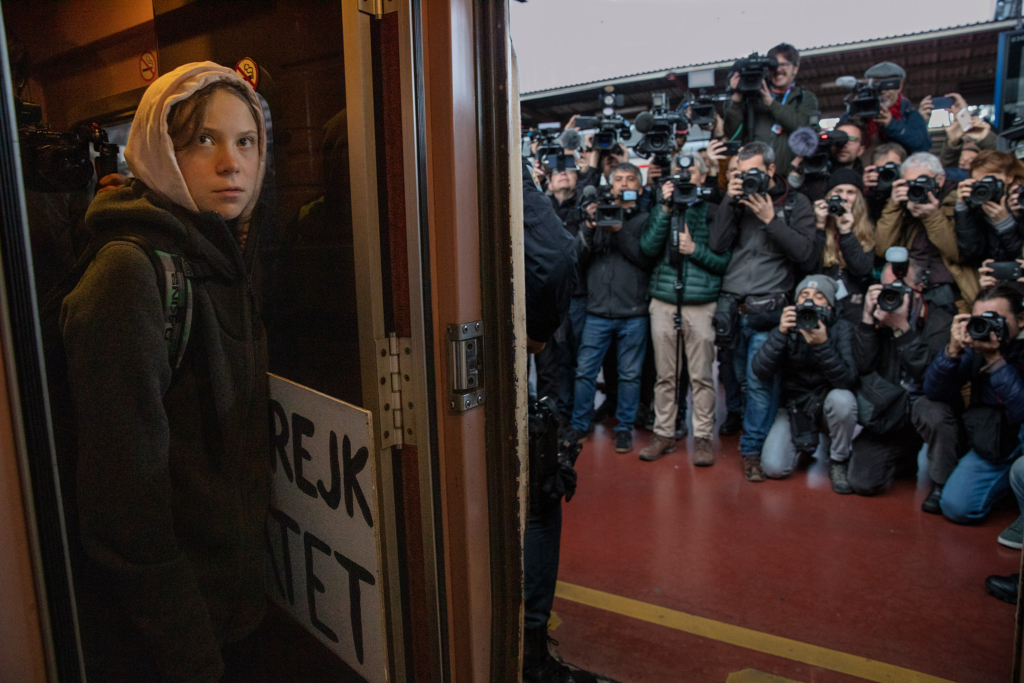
[847, 253, 958, 505]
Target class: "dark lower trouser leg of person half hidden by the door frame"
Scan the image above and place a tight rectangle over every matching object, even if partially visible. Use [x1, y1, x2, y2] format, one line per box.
[522, 501, 562, 629]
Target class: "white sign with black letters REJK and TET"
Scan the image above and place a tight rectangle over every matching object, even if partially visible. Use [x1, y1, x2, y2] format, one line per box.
[265, 375, 387, 683]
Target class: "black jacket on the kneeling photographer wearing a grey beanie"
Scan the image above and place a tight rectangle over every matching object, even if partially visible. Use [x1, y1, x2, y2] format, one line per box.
[751, 318, 857, 409]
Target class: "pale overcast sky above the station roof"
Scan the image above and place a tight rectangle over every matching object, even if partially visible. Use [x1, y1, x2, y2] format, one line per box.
[509, 0, 995, 92]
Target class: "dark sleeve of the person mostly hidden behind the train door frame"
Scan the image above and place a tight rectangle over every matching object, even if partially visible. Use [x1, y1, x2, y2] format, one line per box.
[522, 162, 577, 342]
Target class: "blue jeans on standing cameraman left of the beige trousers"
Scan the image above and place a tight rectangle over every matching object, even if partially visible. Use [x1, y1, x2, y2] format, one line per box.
[572, 314, 648, 432]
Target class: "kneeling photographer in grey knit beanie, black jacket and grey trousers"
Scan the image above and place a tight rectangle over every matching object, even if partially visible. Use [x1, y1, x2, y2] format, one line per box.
[751, 275, 857, 494]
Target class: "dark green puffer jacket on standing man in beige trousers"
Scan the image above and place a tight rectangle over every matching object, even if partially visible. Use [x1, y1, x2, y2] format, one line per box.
[640, 197, 732, 304]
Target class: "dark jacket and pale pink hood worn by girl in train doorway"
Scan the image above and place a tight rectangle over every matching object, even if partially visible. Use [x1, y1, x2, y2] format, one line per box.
[60, 62, 270, 682]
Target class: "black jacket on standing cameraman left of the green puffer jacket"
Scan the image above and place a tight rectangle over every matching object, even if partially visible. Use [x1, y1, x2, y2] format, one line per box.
[580, 204, 657, 317]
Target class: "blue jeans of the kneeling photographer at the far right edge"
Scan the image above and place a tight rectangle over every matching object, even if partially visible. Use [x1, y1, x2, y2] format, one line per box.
[941, 444, 1021, 524]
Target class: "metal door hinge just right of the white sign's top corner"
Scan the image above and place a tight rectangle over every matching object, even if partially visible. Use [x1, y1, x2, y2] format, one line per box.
[376, 333, 416, 449]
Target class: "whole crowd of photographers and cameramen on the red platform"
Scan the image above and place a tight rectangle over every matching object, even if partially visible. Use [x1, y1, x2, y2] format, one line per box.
[532, 44, 1024, 626]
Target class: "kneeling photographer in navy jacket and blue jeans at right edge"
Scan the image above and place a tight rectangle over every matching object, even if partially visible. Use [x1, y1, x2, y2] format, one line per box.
[925, 285, 1024, 524]
